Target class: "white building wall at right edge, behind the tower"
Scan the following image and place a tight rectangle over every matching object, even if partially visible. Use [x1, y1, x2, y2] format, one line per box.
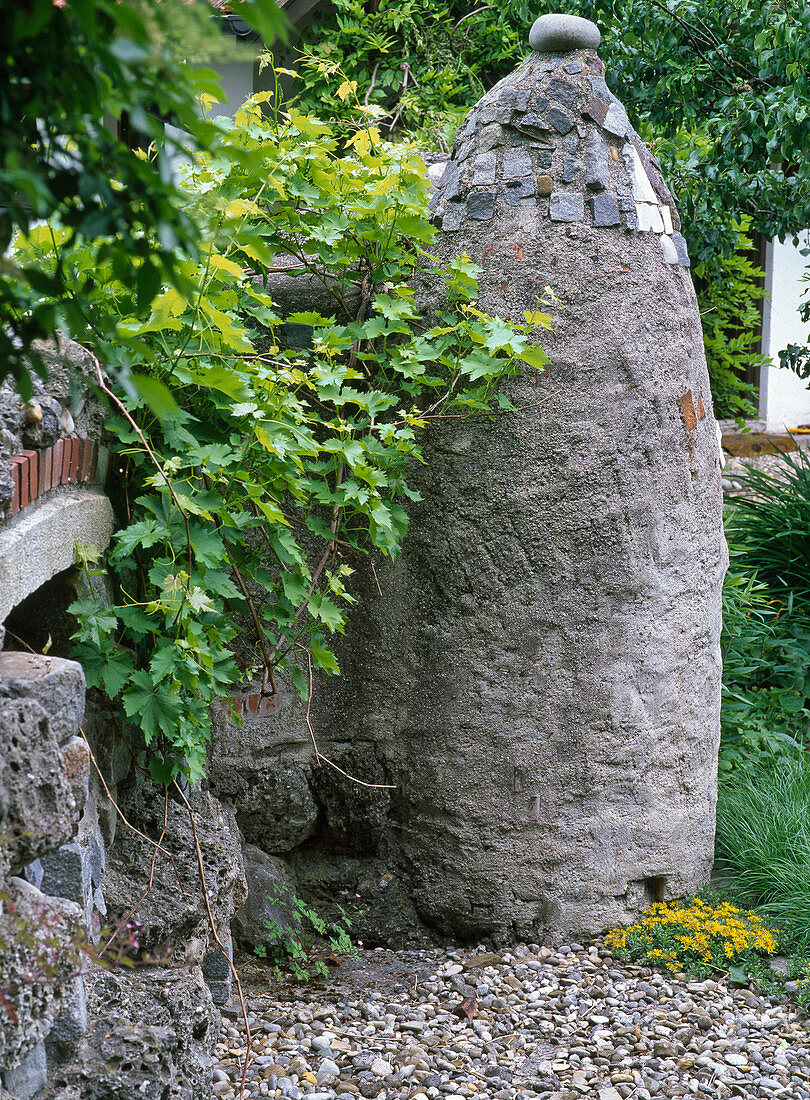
[759, 230, 810, 431]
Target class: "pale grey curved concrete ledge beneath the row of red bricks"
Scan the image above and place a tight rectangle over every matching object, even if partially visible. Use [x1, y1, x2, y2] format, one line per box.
[0, 490, 113, 623]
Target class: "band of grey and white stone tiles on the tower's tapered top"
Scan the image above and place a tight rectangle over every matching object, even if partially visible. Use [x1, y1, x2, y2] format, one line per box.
[430, 50, 689, 268]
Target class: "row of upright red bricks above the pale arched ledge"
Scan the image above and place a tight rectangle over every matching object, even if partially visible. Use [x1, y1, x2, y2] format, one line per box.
[9, 438, 109, 516]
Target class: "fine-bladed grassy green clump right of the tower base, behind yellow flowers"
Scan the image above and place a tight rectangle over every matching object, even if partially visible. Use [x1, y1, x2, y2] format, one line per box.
[716, 755, 810, 948]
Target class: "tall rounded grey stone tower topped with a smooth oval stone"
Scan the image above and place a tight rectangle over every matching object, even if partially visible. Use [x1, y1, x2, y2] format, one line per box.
[223, 15, 726, 939]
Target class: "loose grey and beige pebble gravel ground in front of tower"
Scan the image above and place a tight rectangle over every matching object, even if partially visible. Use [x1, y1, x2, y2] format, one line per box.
[214, 944, 810, 1100]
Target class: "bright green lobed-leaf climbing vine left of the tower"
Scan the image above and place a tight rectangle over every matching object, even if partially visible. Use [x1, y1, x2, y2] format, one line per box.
[18, 79, 549, 782]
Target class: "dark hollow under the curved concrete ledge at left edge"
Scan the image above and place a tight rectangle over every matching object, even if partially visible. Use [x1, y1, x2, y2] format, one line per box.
[3, 567, 81, 657]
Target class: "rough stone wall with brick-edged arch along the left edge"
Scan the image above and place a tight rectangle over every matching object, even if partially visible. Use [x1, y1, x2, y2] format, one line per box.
[0, 342, 247, 1100]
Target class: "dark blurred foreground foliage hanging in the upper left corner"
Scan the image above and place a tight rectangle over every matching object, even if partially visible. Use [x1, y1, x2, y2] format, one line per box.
[0, 0, 283, 396]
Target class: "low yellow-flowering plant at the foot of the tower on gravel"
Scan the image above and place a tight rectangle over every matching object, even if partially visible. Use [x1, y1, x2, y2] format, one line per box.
[605, 898, 777, 980]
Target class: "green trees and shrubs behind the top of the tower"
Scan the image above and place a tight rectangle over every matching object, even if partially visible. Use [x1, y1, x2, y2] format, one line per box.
[290, 0, 810, 416]
